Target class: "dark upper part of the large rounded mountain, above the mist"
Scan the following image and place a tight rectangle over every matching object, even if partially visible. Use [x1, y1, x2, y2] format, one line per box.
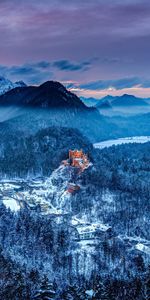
[0, 81, 86, 109]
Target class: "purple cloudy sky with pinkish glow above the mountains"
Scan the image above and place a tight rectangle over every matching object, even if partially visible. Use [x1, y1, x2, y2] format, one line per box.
[0, 0, 150, 98]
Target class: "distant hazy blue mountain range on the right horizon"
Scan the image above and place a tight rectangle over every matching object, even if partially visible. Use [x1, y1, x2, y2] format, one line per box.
[96, 94, 148, 108]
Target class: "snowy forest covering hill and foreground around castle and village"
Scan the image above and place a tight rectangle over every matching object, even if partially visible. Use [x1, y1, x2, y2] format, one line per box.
[0, 120, 150, 300]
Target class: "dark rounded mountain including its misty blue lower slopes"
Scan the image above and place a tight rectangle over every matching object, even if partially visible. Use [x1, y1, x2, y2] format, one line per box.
[0, 81, 117, 142]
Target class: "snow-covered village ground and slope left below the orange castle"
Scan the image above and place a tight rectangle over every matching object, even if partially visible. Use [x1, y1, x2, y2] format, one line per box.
[0, 165, 71, 215]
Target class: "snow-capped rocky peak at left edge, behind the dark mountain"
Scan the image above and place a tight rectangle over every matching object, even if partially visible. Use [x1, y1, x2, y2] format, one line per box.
[0, 77, 26, 95]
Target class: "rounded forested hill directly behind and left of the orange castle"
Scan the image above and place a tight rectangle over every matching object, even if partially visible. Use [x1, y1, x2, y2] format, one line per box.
[0, 123, 92, 177]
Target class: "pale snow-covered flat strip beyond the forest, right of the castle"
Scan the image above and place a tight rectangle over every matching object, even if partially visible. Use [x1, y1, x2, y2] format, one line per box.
[94, 136, 150, 149]
